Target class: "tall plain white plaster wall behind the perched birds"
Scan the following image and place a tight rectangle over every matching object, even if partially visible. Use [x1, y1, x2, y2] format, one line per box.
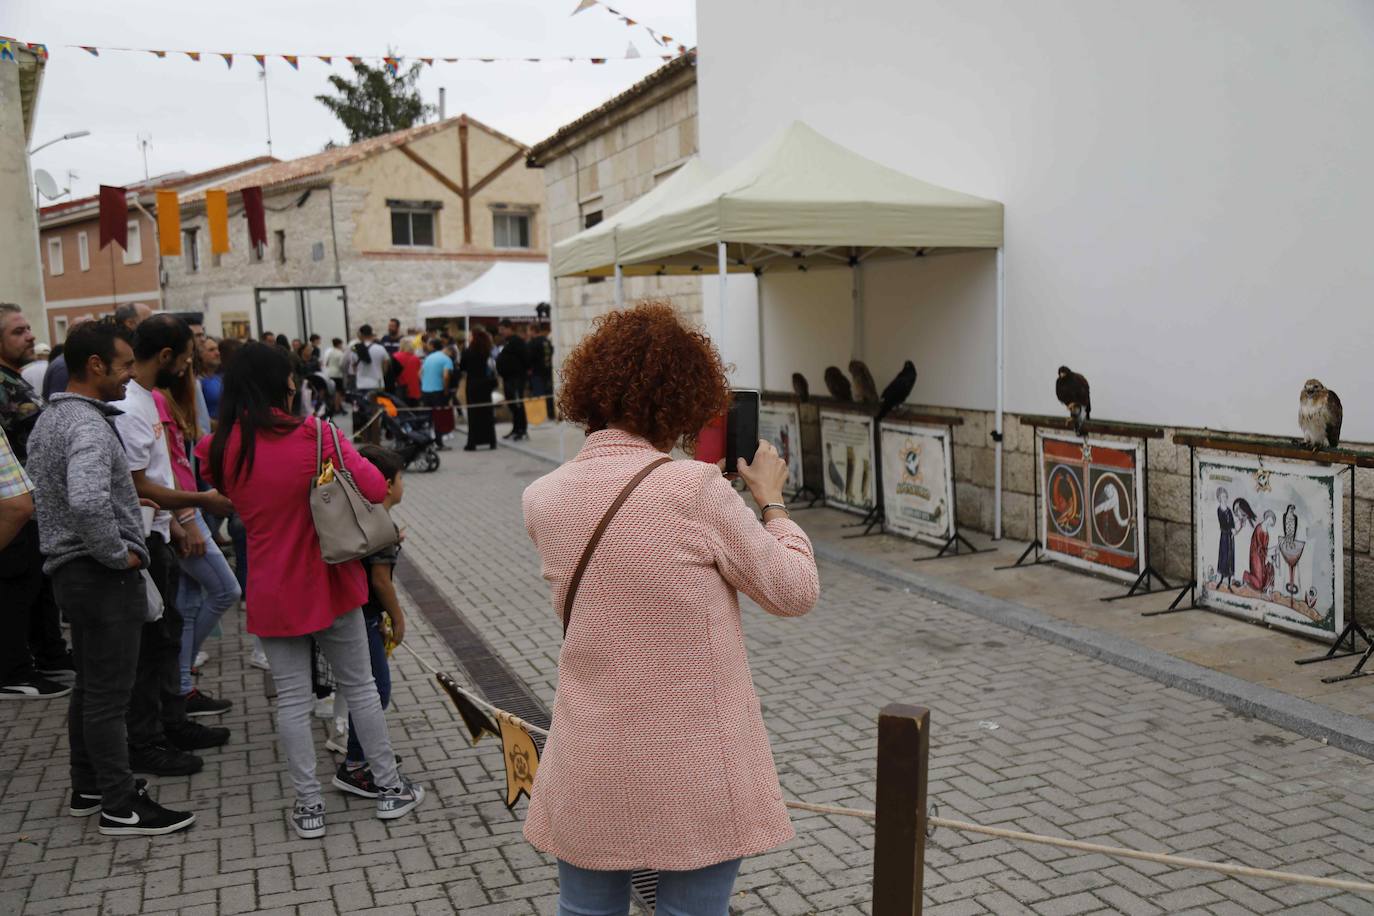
[697, 0, 1374, 441]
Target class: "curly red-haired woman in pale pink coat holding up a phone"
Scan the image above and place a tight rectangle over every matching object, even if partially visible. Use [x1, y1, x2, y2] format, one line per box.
[523, 304, 819, 916]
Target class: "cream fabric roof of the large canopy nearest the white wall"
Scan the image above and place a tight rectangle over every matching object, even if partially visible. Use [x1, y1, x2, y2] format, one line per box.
[616, 121, 1002, 272]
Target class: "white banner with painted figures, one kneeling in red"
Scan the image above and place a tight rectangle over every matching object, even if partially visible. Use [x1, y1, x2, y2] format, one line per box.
[1193, 450, 1345, 639]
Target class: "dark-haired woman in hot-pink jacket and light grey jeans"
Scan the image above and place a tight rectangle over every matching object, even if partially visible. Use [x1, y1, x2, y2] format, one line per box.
[195, 342, 425, 839]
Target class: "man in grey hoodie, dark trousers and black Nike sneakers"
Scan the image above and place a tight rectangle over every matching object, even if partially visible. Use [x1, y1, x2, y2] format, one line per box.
[27, 319, 195, 836]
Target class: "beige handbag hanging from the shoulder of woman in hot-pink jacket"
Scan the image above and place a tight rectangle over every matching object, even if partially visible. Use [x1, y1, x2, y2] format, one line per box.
[311, 417, 401, 563]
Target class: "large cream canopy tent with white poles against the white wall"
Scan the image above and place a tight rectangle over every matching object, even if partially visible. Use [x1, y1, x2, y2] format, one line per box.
[554, 122, 1006, 537]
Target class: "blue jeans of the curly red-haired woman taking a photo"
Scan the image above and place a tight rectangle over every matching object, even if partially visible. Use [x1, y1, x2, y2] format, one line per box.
[558, 858, 741, 916]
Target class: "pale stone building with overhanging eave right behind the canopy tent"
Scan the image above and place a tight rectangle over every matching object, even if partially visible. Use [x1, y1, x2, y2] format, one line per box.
[529, 52, 702, 370]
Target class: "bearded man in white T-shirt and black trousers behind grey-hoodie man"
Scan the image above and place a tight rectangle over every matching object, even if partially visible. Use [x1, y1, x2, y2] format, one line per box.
[114, 314, 234, 776]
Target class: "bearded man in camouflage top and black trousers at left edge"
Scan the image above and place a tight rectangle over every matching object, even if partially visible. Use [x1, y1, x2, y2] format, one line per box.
[0, 302, 76, 699]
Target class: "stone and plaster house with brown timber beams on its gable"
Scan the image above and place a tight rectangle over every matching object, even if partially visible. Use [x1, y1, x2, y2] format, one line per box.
[164, 115, 548, 339]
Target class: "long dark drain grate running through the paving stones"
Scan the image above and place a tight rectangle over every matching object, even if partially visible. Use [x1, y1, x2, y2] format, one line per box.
[396, 552, 658, 912]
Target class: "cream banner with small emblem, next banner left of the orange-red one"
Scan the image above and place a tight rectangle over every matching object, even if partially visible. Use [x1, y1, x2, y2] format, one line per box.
[878, 422, 955, 545]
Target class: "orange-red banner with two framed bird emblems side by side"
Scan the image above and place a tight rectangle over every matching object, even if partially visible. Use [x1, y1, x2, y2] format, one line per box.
[1036, 433, 1146, 581]
